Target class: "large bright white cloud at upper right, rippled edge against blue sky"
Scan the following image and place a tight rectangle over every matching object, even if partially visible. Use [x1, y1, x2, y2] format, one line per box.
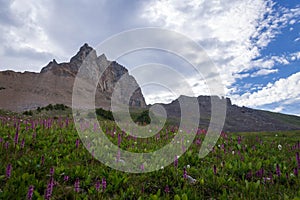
[142, 0, 300, 87]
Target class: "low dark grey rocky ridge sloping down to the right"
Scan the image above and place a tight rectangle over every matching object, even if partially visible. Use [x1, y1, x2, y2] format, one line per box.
[160, 96, 300, 132]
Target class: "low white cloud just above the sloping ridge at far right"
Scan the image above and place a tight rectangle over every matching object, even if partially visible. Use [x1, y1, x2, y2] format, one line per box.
[232, 72, 300, 107]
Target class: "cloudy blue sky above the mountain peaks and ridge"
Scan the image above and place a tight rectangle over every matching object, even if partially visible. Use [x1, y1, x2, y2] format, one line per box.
[0, 0, 300, 115]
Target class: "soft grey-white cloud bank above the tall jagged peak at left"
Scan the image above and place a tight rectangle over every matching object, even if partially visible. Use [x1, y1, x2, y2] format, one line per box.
[0, 0, 147, 71]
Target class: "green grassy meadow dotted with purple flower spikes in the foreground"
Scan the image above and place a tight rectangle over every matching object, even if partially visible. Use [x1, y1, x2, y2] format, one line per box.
[0, 115, 300, 199]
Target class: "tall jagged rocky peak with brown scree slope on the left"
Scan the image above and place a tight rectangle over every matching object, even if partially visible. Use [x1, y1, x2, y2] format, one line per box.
[0, 44, 146, 111]
